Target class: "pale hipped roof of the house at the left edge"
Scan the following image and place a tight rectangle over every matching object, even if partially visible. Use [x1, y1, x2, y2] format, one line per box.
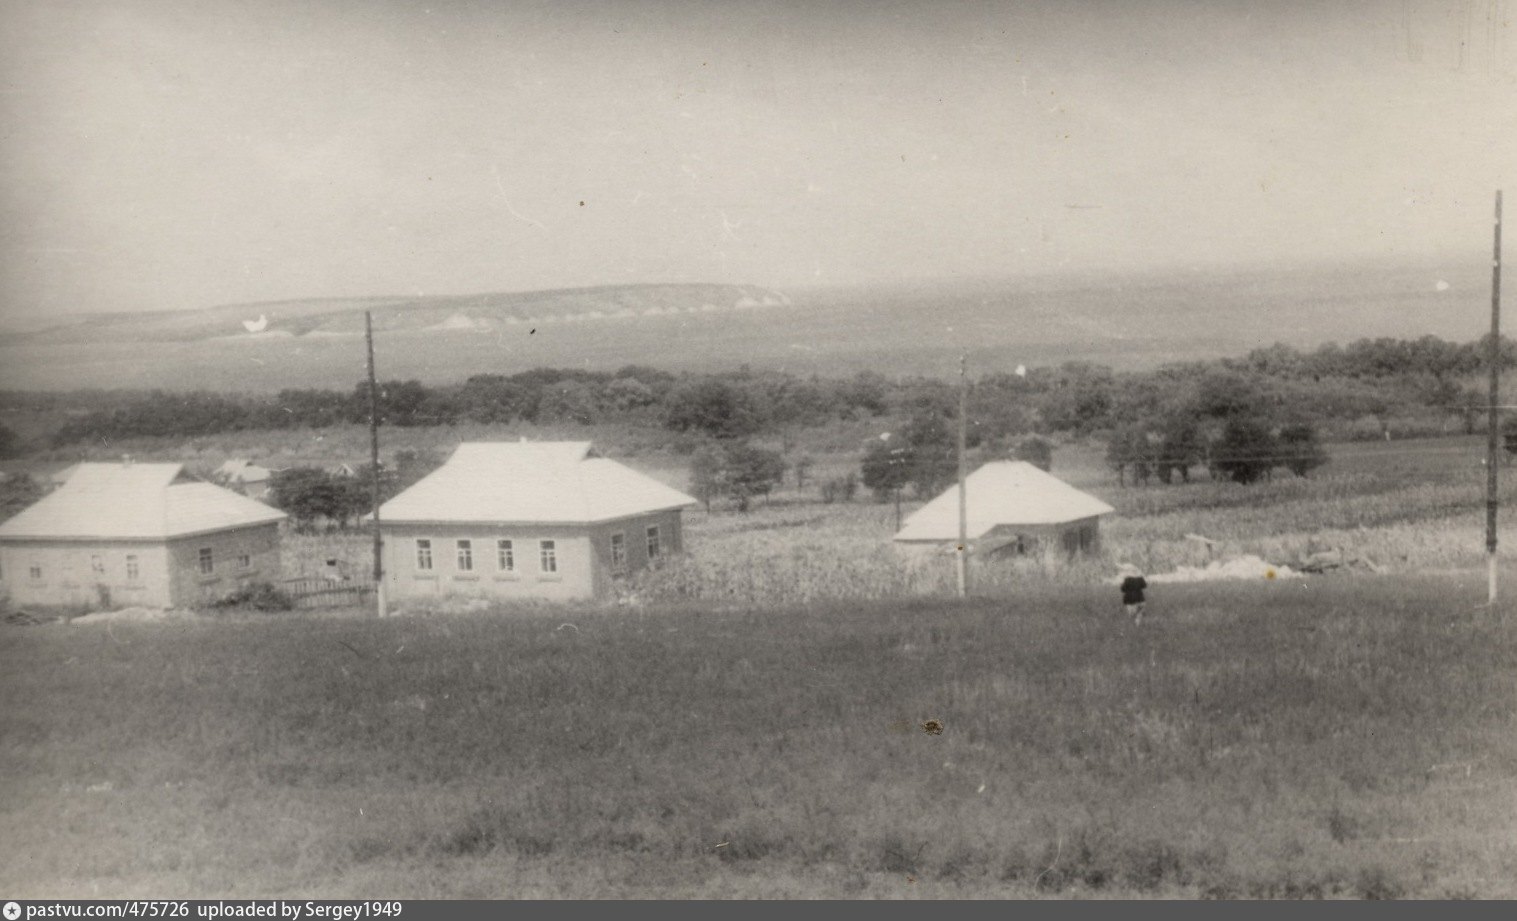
[0, 464, 285, 540]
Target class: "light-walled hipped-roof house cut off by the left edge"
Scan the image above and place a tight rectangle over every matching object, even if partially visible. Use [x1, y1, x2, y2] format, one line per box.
[0, 463, 285, 608]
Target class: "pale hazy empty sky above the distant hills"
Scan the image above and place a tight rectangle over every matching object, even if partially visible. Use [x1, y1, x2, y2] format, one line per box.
[0, 0, 1517, 313]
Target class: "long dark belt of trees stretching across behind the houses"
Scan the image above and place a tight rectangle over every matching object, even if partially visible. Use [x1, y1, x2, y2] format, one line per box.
[14, 337, 1517, 458]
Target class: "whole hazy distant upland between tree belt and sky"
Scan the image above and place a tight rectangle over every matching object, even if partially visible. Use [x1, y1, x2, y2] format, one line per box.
[0, 256, 1491, 391]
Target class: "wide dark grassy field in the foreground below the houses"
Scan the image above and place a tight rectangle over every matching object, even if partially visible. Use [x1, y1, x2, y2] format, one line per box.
[0, 574, 1517, 898]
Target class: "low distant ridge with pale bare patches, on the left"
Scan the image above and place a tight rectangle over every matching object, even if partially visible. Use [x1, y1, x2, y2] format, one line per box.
[0, 284, 790, 346]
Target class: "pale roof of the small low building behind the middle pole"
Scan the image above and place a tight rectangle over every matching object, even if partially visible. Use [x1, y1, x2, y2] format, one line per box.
[895, 461, 1115, 540]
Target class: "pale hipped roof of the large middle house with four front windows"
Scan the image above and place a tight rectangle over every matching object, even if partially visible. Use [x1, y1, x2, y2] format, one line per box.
[379, 442, 695, 523]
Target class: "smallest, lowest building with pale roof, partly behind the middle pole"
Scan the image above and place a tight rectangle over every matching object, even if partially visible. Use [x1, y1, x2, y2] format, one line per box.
[895, 461, 1115, 557]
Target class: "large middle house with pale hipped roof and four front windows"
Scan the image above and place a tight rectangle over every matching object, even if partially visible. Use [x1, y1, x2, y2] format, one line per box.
[379, 442, 695, 601]
